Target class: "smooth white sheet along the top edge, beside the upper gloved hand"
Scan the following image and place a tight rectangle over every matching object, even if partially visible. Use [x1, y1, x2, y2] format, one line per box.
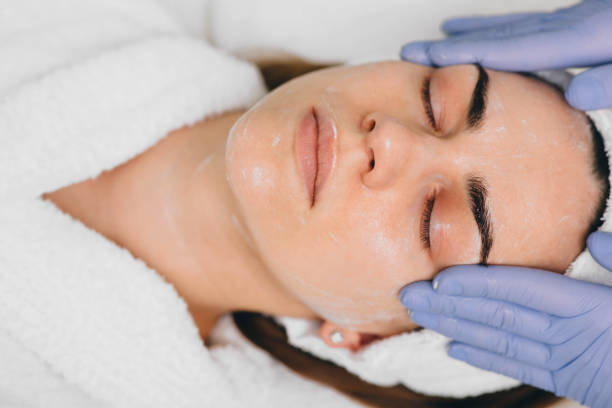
[208, 0, 578, 63]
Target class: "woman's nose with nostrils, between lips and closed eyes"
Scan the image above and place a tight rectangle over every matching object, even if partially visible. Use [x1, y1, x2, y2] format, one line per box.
[362, 112, 436, 189]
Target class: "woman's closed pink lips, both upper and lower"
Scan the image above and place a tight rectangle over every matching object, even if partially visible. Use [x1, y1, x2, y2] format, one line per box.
[295, 108, 336, 207]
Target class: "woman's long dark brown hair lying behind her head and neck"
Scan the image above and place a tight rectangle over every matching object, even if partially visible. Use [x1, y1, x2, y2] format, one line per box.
[233, 59, 558, 408]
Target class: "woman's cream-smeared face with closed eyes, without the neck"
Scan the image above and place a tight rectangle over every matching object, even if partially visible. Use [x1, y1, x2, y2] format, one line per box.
[226, 62, 599, 334]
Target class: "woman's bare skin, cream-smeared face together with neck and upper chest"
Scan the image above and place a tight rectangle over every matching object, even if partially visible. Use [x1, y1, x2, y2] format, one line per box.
[44, 62, 600, 345]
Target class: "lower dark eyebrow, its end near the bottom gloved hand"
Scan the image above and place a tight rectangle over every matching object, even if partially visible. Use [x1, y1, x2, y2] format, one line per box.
[466, 175, 493, 265]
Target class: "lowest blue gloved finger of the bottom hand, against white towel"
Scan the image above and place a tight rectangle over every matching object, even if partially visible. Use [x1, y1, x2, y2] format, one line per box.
[448, 342, 555, 392]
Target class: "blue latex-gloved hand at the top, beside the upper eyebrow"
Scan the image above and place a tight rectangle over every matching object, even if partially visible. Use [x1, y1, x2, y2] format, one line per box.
[400, 0, 612, 110]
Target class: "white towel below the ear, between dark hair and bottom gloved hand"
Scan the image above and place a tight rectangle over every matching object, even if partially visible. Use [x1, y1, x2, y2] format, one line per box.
[276, 317, 519, 398]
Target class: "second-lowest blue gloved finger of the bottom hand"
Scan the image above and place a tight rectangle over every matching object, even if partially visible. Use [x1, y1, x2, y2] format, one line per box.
[410, 312, 551, 368]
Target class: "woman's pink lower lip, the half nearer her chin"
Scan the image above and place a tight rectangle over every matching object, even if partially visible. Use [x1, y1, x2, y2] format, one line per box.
[295, 109, 319, 207]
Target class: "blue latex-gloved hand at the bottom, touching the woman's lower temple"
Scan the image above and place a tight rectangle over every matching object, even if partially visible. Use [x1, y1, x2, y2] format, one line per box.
[400, 232, 612, 408]
